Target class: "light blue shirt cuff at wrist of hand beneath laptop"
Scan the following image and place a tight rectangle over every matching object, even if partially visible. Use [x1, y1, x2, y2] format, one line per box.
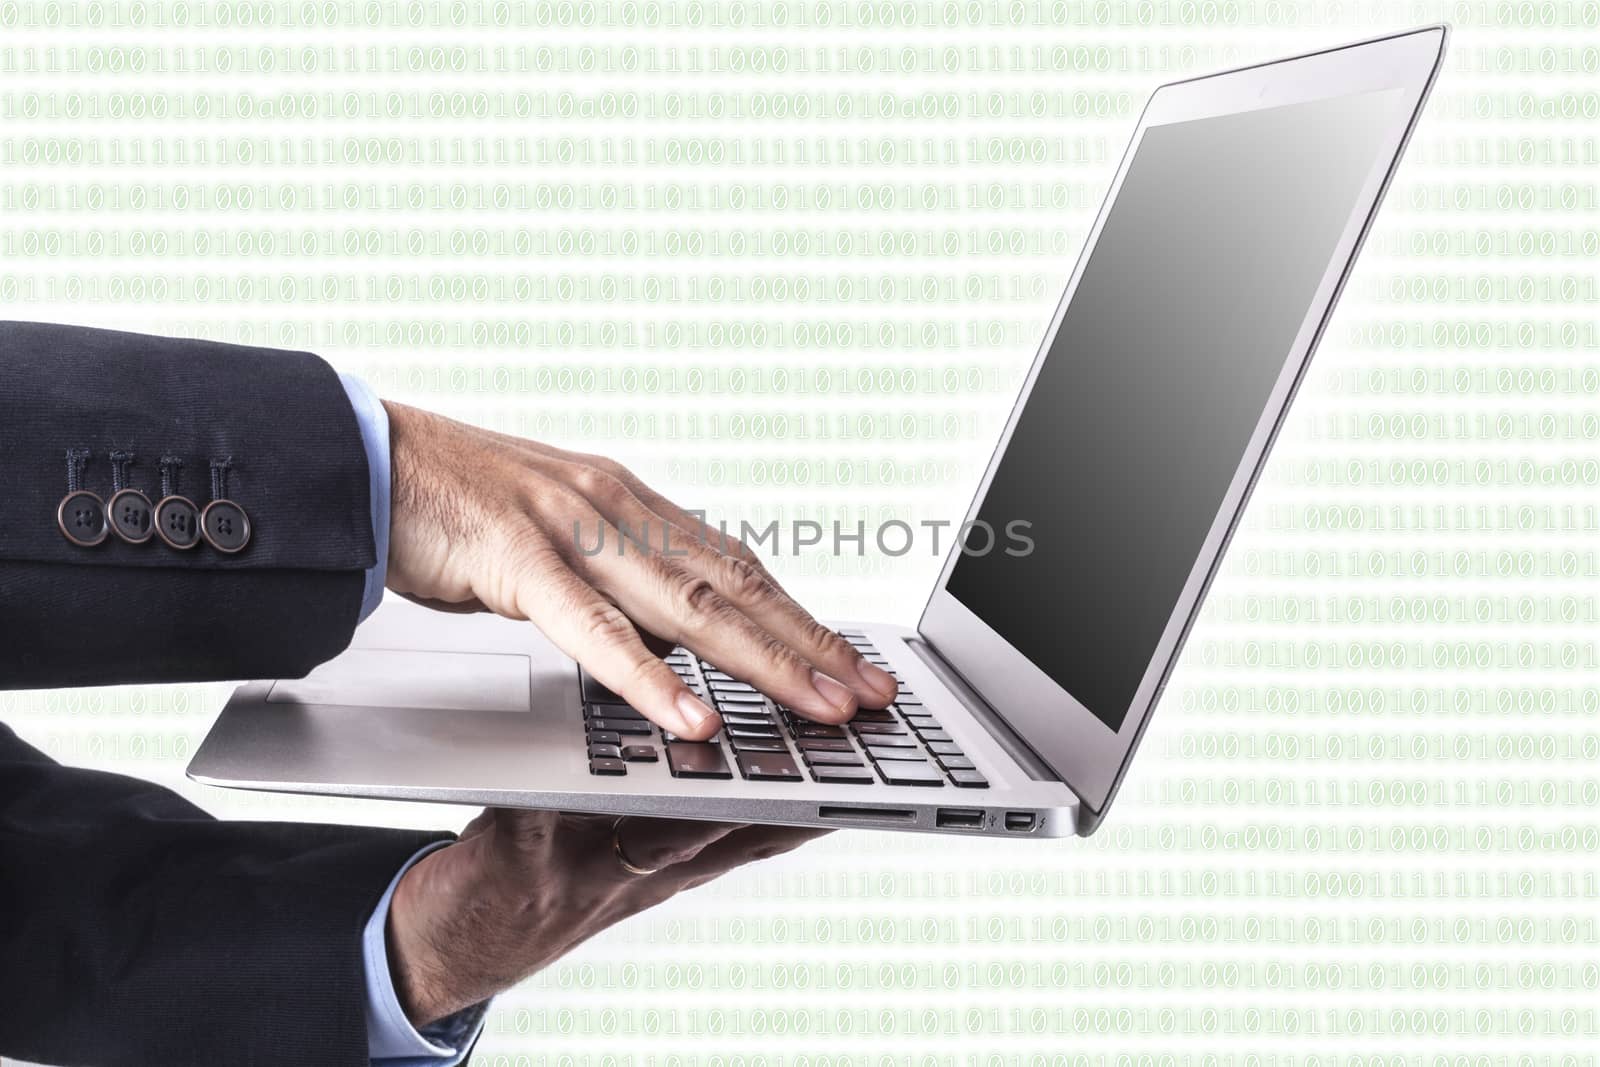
[362, 841, 490, 1067]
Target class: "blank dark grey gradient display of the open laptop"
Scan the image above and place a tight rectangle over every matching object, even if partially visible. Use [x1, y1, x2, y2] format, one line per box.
[947, 90, 1402, 731]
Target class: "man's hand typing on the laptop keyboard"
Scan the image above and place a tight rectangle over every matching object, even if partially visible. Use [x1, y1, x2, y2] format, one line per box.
[376, 403, 896, 741]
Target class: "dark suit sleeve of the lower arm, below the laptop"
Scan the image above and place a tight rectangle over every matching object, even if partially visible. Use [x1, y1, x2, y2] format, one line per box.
[0, 725, 446, 1067]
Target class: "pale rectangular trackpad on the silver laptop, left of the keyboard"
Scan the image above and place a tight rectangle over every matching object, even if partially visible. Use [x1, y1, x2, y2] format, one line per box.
[267, 648, 531, 712]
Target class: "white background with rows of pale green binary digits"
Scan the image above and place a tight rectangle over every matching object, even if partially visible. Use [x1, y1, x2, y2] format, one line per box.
[0, 0, 1600, 1065]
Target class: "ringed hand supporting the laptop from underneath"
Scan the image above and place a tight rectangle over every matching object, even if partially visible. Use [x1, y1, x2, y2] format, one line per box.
[389, 808, 827, 1027]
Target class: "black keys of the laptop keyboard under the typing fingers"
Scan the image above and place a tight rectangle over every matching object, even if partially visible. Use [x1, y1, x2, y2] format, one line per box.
[581, 630, 989, 789]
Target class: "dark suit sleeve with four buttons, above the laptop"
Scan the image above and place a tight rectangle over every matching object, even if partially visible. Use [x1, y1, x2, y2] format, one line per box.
[0, 322, 374, 689]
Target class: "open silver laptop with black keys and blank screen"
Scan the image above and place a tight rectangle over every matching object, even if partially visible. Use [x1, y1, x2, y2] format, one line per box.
[189, 26, 1448, 838]
